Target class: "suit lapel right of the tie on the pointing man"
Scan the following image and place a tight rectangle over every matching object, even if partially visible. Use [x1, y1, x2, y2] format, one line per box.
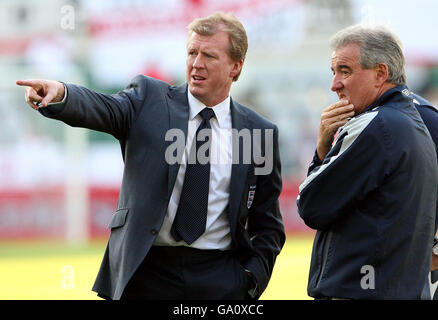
[229, 99, 250, 235]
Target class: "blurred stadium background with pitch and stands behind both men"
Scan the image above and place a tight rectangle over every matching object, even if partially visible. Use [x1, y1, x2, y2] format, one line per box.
[0, 0, 438, 299]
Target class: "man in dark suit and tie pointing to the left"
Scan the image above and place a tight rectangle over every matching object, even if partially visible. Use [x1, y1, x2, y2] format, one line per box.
[17, 13, 285, 299]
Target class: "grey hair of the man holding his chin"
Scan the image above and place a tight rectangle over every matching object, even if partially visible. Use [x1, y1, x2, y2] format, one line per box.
[330, 24, 406, 85]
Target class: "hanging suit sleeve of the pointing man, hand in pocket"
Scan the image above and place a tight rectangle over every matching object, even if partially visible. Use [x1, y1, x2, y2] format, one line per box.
[245, 127, 285, 298]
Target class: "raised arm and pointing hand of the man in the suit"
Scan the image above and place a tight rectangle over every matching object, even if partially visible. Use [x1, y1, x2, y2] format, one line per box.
[17, 75, 148, 140]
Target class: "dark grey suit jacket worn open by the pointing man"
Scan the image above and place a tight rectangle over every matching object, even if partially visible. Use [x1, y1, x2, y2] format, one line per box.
[39, 75, 285, 299]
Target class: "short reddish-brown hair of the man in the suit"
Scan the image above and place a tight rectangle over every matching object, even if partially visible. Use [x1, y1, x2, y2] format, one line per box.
[187, 11, 248, 81]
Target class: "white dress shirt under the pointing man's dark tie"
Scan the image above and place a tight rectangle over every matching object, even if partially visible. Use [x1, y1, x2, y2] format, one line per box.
[154, 90, 236, 250]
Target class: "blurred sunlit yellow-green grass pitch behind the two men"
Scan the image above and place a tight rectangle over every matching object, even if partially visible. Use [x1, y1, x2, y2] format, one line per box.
[0, 234, 313, 300]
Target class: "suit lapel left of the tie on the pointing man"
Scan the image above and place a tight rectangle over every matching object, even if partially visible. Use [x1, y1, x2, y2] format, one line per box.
[166, 84, 189, 196]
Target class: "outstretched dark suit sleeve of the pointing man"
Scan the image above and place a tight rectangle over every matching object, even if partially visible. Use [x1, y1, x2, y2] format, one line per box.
[39, 76, 147, 140]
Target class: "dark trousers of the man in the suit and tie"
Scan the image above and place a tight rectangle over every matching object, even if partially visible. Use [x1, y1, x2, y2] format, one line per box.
[121, 246, 249, 300]
